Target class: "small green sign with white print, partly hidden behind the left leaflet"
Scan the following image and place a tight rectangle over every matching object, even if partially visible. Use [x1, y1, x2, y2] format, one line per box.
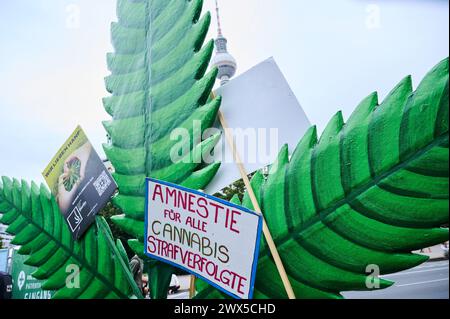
[11, 251, 53, 299]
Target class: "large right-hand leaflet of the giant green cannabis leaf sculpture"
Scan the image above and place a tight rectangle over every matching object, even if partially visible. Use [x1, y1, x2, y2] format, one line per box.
[198, 59, 449, 298]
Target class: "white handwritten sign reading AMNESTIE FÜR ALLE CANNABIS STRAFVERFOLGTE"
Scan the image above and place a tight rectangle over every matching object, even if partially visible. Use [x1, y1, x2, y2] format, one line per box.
[145, 179, 262, 299]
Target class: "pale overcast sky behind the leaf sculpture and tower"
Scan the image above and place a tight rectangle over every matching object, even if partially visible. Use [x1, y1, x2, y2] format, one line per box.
[0, 0, 449, 181]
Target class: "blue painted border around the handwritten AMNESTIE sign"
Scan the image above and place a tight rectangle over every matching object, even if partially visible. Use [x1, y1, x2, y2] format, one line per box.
[144, 178, 263, 299]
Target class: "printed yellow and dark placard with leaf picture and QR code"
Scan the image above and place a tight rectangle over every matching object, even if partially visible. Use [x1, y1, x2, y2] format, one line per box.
[42, 127, 117, 240]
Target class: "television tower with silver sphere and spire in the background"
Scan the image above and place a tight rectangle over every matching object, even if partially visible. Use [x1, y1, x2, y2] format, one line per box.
[211, 0, 237, 86]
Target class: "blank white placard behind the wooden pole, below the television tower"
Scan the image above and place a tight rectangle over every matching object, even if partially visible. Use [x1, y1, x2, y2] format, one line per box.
[205, 58, 311, 194]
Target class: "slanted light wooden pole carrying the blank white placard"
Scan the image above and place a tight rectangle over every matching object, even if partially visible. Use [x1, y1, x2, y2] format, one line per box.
[213, 107, 296, 299]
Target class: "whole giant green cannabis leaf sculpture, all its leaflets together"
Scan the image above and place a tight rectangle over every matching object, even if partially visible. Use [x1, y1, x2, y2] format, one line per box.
[0, 0, 449, 299]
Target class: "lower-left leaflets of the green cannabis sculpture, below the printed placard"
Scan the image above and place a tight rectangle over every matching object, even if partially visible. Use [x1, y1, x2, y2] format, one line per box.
[0, 177, 132, 299]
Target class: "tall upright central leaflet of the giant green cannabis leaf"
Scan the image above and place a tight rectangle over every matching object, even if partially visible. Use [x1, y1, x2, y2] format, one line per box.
[104, 0, 220, 297]
